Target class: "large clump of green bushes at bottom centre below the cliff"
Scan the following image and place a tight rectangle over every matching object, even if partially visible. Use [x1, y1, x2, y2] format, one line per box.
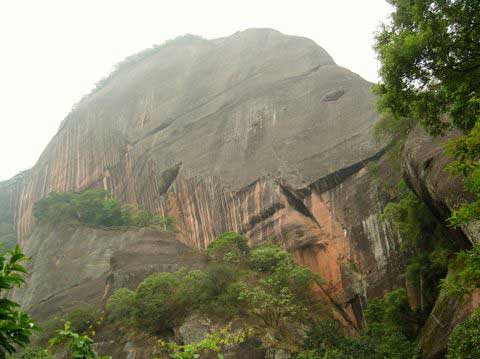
[107, 233, 324, 350]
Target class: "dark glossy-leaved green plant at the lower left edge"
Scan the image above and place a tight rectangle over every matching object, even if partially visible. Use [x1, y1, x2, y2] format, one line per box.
[0, 246, 36, 354]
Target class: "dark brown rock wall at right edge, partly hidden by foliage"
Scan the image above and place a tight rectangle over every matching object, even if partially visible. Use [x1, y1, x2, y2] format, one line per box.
[403, 127, 480, 359]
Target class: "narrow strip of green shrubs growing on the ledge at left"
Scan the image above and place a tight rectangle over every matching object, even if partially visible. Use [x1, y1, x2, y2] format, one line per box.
[33, 189, 174, 230]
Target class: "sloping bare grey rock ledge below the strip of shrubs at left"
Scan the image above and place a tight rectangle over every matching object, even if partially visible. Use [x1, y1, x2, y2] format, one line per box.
[14, 225, 204, 320]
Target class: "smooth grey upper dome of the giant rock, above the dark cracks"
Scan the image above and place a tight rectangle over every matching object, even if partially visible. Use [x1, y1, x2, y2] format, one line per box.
[12, 29, 380, 246]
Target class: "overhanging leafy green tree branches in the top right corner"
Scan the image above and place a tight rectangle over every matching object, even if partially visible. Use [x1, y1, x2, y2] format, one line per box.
[376, 0, 480, 134]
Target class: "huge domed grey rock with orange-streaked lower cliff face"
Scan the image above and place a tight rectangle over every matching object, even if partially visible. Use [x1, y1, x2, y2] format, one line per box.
[6, 29, 403, 332]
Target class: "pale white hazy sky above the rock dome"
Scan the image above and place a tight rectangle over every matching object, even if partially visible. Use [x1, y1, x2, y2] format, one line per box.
[0, 0, 390, 180]
